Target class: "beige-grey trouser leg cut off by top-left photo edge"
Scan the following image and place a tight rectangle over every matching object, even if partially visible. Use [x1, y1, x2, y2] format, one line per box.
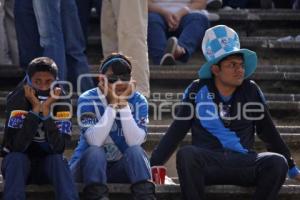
[0, 0, 12, 64]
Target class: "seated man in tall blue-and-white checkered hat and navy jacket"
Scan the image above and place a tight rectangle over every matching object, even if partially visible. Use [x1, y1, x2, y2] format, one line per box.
[151, 25, 300, 200]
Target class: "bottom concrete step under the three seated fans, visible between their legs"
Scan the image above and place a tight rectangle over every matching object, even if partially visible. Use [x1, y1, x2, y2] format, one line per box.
[0, 181, 300, 200]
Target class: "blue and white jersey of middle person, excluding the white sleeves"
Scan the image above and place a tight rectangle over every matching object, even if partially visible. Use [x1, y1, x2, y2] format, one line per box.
[69, 88, 148, 165]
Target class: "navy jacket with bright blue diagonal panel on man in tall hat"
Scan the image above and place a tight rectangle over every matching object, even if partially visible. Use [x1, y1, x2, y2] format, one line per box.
[151, 79, 295, 169]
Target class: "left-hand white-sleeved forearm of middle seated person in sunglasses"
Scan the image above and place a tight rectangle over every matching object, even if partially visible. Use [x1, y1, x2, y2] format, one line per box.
[84, 106, 116, 147]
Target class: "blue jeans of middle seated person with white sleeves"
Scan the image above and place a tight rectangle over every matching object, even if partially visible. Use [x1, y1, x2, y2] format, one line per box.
[70, 146, 151, 185]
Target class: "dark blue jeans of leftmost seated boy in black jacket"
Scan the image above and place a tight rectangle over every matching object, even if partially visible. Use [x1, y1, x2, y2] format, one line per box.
[1, 152, 79, 200]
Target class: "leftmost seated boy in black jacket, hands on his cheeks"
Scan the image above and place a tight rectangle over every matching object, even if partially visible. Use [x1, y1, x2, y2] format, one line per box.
[2, 57, 78, 200]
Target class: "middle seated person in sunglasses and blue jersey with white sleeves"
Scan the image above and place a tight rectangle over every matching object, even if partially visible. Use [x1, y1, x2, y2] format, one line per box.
[70, 54, 155, 200]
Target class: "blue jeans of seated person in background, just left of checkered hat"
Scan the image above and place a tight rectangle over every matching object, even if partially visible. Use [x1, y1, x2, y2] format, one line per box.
[148, 12, 209, 65]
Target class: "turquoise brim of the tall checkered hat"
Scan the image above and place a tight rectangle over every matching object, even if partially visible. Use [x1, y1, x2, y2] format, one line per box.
[198, 49, 257, 79]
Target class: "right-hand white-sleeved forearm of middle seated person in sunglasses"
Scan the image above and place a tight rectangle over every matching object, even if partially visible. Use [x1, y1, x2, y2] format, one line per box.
[119, 105, 146, 146]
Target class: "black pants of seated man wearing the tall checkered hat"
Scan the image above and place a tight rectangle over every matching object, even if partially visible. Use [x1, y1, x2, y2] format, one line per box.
[176, 145, 288, 200]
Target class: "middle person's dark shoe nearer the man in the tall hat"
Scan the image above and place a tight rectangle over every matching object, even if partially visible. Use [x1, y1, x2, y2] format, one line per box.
[131, 181, 156, 200]
